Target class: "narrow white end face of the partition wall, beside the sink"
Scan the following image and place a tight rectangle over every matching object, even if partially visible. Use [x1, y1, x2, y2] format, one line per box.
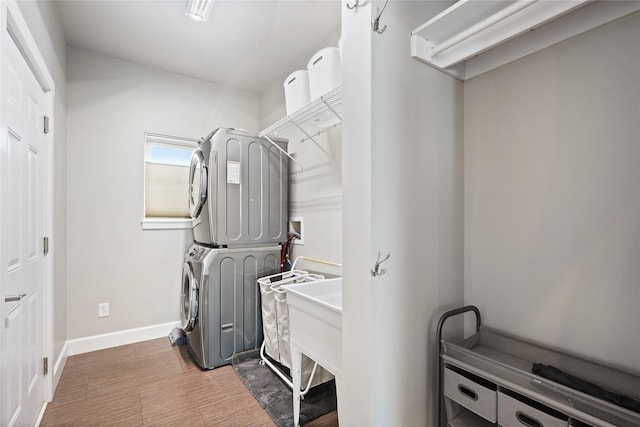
[338, 1, 374, 426]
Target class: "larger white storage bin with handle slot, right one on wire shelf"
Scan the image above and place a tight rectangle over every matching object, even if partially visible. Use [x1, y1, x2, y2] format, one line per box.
[307, 47, 342, 101]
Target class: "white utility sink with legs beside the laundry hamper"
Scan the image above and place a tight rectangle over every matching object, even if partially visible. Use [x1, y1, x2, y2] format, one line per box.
[282, 277, 342, 426]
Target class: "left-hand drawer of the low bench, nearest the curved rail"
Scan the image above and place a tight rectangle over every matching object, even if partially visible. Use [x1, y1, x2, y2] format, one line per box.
[443, 366, 497, 423]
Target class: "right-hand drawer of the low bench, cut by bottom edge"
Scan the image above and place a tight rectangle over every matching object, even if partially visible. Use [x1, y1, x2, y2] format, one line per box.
[498, 389, 569, 427]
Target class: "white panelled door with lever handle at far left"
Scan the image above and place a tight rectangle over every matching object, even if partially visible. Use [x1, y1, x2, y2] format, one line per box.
[0, 27, 46, 426]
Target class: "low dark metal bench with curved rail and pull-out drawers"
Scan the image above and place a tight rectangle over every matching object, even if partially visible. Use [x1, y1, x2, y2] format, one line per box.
[436, 306, 640, 427]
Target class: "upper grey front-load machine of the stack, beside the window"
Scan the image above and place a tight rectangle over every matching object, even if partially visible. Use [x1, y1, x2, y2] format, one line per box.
[189, 128, 289, 248]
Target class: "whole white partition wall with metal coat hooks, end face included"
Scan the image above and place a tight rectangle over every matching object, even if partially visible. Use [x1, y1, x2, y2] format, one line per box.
[341, 1, 464, 426]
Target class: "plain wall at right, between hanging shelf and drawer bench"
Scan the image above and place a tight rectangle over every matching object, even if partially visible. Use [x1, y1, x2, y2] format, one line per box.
[464, 13, 640, 371]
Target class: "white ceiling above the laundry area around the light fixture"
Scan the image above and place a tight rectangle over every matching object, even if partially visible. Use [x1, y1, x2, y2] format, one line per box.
[55, 0, 341, 93]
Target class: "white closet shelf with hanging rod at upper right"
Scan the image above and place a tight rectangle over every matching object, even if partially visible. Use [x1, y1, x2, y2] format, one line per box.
[411, 0, 640, 80]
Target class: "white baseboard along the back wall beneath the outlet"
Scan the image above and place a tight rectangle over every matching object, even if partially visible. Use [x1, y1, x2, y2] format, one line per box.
[62, 321, 181, 356]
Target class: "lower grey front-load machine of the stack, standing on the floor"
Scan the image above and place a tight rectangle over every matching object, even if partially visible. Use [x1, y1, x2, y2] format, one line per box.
[181, 244, 280, 369]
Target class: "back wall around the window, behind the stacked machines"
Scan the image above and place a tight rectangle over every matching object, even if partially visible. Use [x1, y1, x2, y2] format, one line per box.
[67, 49, 259, 339]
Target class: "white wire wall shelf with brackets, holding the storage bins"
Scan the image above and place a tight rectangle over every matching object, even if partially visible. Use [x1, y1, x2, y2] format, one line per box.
[260, 86, 342, 169]
